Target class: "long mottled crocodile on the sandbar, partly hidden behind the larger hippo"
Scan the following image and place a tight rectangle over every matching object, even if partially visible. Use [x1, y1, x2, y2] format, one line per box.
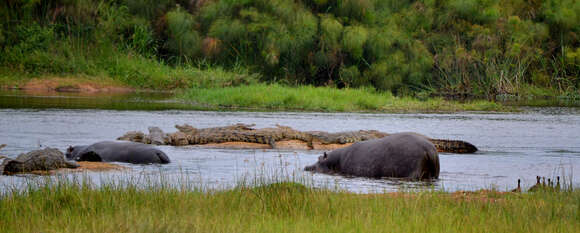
[117, 124, 477, 153]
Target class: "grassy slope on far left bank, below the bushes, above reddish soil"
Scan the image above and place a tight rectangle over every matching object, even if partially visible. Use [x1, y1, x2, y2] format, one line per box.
[0, 51, 259, 90]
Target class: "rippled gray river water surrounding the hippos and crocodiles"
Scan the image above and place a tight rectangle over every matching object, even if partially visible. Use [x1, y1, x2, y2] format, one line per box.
[0, 91, 580, 193]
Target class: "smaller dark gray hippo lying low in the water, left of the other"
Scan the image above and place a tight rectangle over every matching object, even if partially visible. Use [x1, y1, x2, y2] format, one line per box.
[66, 141, 170, 164]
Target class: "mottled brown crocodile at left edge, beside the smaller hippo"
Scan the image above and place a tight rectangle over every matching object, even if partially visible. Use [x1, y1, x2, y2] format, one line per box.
[0, 148, 79, 175]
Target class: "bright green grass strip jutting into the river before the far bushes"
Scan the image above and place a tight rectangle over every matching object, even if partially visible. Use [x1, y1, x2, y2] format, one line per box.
[177, 84, 510, 112]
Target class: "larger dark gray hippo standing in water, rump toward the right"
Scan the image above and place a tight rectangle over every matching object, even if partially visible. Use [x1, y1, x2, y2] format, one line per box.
[304, 133, 439, 179]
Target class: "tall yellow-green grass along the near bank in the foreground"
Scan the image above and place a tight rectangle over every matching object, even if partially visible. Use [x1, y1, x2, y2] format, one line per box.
[0, 177, 580, 232]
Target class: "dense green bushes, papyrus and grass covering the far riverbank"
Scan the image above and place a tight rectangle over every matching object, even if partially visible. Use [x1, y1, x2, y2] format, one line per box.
[0, 0, 580, 111]
